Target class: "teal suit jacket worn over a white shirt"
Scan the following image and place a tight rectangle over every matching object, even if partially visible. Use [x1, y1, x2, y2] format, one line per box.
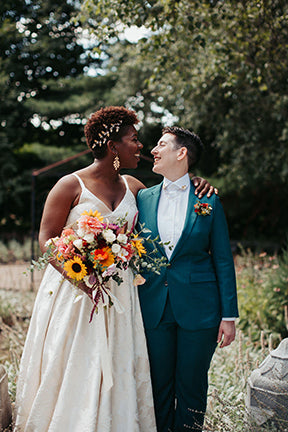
[137, 182, 238, 330]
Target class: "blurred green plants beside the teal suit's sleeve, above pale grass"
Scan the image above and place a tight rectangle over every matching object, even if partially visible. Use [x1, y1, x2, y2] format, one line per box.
[236, 243, 288, 341]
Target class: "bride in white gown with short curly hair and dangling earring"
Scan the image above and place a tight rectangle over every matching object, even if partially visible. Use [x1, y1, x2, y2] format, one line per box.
[14, 107, 212, 432]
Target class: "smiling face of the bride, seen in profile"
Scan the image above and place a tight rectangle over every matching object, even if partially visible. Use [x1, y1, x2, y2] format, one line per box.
[116, 126, 143, 168]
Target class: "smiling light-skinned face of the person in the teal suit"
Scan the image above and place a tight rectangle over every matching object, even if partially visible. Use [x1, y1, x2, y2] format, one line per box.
[151, 133, 181, 181]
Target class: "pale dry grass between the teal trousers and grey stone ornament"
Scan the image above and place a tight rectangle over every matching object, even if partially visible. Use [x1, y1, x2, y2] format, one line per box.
[205, 330, 288, 432]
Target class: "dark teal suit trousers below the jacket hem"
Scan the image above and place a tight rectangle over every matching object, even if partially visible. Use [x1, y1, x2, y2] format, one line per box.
[146, 297, 218, 432]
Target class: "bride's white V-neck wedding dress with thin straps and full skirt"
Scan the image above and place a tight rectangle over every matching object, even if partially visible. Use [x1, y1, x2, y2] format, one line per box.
[15, 176, 156, 432]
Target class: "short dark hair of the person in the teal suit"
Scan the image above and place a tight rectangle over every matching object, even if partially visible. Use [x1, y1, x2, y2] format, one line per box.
[162, 126, 204, 169]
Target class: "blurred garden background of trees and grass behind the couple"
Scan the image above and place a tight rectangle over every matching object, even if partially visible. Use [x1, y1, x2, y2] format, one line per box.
[0, 0, 288, 431]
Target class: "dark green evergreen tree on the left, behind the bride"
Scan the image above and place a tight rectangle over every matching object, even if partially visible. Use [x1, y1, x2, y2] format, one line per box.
[0, 0, 113, 236]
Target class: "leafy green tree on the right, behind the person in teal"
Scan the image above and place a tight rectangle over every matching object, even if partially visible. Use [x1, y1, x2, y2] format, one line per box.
[82, 0, 288, 238]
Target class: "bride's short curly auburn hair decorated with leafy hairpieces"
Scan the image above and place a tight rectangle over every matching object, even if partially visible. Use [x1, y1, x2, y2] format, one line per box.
[84, 106, 139, 159]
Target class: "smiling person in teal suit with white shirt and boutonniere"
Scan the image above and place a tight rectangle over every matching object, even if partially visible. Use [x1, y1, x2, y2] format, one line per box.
[137, 127, 238, 432]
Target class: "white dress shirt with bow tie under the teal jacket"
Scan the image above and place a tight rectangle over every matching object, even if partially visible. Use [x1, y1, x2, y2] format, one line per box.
[157, 173, 235, 321]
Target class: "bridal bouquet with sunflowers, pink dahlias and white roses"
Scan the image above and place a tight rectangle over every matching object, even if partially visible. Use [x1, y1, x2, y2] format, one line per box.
[32, 210, 166, 321]
